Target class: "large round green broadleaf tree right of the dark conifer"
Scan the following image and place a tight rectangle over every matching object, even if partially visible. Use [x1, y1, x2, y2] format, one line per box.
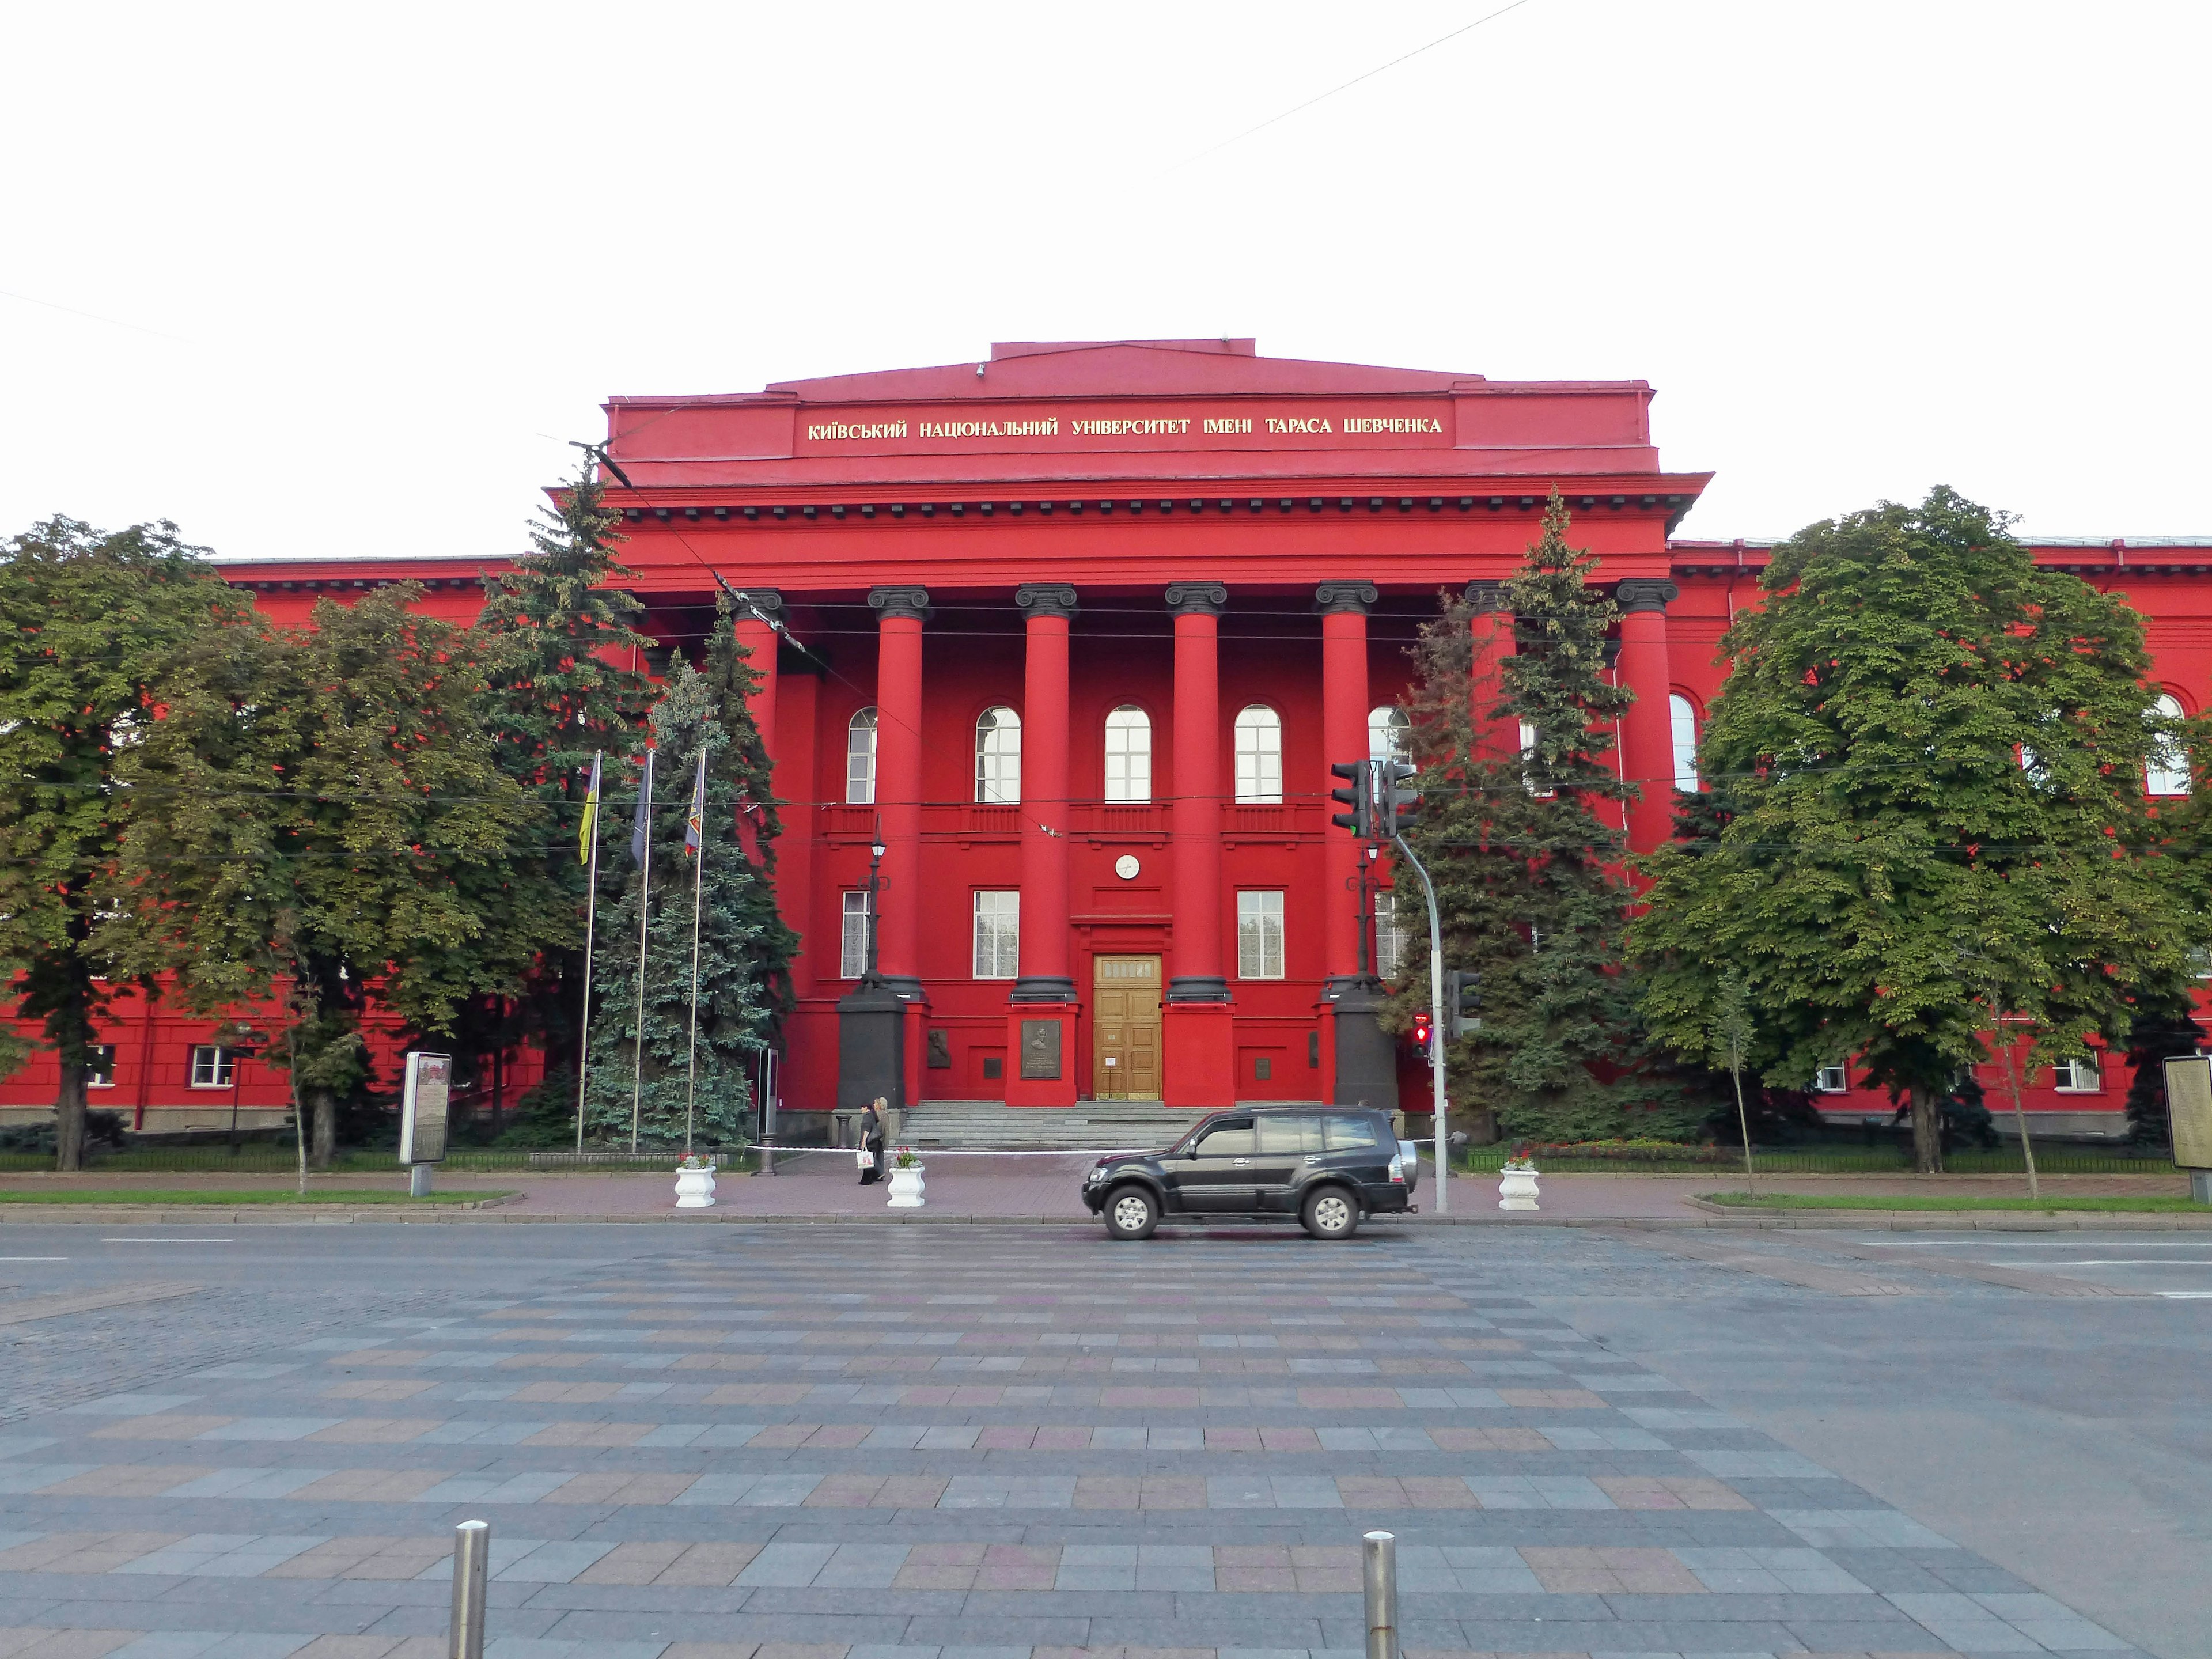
[1633, 489, 2203, 1170]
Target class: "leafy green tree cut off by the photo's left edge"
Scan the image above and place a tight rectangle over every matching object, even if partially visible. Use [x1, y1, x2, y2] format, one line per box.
[0, 518, 245, 1170]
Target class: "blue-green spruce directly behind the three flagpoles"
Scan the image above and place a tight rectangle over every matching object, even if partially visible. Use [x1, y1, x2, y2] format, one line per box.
[586, 628, 796, 1146]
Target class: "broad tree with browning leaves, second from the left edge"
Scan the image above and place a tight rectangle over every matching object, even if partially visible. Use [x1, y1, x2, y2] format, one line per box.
[100, 584, 560, 1185]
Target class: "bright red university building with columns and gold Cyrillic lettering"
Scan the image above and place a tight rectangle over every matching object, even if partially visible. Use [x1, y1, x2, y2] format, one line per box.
[7, 340, 2212, 1130]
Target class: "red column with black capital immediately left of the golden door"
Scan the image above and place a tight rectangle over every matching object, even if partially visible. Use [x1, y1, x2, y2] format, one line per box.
[1013, 582, 1075, 999]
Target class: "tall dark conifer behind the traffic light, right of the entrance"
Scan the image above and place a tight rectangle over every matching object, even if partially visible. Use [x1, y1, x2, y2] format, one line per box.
[1391, 491, 1706, 1141]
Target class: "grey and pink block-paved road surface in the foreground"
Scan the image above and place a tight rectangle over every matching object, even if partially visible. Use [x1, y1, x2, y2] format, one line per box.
[0, 1224, 2207, 1659]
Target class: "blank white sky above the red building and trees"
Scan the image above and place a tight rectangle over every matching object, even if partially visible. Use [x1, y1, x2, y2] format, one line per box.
[0, 0, 2212, 558]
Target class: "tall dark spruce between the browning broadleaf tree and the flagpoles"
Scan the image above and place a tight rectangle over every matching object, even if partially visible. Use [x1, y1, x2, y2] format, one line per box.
[471, 464, 653, 1111]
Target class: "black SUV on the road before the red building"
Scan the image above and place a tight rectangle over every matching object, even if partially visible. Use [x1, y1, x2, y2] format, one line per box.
[1084, 1106, 1420, 1238]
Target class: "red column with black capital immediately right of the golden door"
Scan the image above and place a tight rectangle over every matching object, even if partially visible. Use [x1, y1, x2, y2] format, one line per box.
[1168, 582, 1230, 1002]
